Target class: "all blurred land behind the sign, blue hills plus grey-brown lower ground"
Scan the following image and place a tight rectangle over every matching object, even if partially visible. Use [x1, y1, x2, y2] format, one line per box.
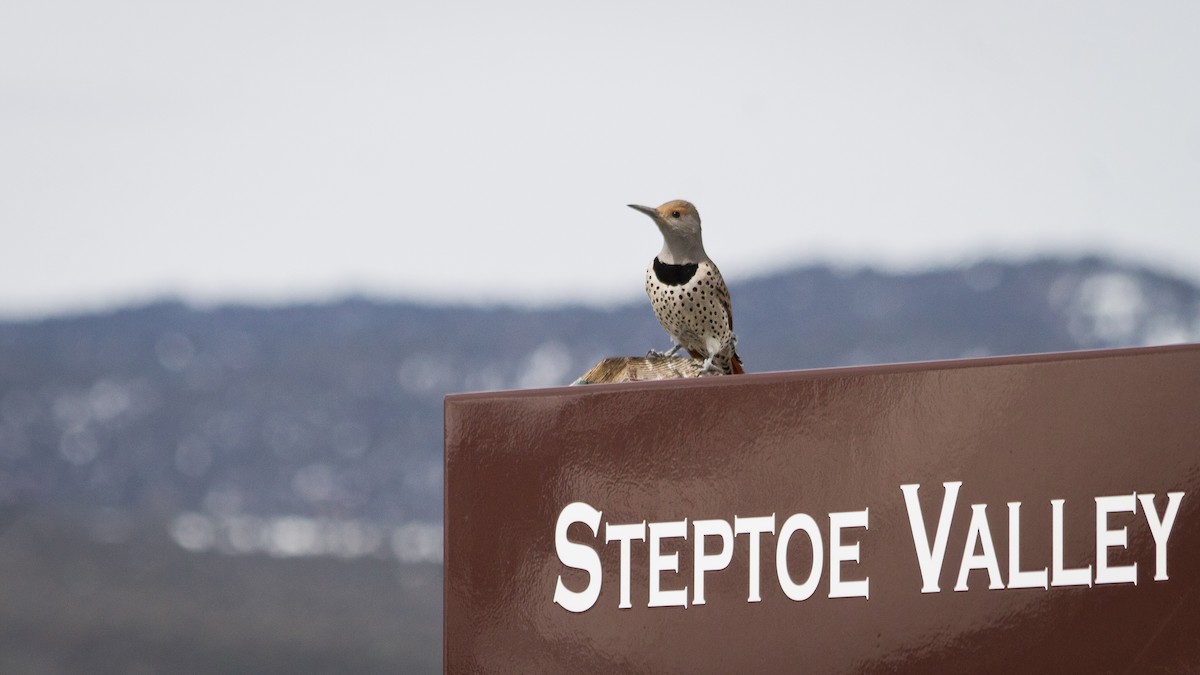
[0, 254, 1200, 675]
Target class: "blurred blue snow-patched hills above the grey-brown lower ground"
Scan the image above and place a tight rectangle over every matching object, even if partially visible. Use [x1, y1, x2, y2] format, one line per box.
[0, 254, 1200, 524]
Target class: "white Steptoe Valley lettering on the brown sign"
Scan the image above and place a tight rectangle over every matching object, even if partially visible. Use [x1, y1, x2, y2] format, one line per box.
[547, 480, 1184, 613]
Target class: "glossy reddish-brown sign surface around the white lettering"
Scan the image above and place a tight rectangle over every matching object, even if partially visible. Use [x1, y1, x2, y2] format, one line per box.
[445, 346, 1200, 673]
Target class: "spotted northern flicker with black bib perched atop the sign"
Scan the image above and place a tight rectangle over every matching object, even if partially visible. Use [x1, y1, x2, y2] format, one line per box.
[629, 199, 744, 375]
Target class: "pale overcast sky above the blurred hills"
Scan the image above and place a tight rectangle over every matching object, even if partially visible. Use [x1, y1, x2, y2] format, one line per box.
[0, 0, 1200, 316]
